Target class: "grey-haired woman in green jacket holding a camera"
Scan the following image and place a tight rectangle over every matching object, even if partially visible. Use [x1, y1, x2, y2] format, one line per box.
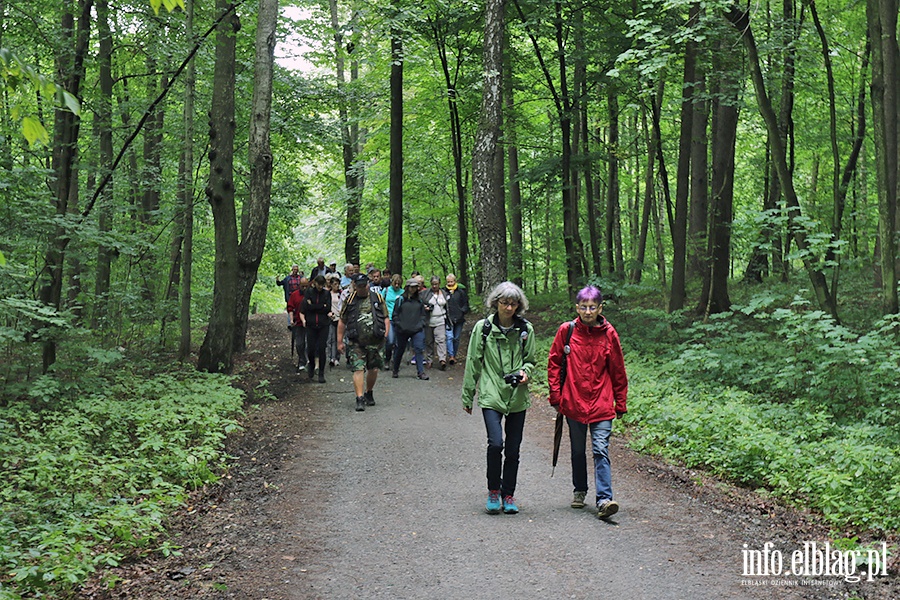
[462, 281, 535, 514]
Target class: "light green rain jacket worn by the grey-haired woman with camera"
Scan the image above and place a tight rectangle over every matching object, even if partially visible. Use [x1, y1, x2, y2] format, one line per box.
[462, 315, 535, 415]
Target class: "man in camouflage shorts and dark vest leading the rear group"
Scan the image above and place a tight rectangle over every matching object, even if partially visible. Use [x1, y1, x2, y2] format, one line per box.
[337, 273, 391, 412]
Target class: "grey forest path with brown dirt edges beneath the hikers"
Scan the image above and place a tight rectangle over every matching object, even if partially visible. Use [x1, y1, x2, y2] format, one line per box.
[78, 315, 900, 600]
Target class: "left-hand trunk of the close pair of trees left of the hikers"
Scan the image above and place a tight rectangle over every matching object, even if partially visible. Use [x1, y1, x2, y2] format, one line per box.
[197, 0, 240, 373]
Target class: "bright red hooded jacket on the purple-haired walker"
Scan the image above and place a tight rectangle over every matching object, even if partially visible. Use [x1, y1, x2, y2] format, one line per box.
[547, 315, 628, 423]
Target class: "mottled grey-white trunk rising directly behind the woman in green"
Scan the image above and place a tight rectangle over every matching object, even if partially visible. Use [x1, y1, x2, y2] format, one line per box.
[472, 0, 507, 289]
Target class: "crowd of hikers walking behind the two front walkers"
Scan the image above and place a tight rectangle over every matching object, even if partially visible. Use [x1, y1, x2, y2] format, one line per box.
[276, 257, 470, 411]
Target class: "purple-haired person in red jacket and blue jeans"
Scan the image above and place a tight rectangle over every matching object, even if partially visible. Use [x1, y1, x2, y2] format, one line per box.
[547, 286, 628, 519]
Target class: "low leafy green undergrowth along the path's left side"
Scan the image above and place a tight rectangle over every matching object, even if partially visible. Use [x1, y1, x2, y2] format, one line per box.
[0, 366, 242, 598]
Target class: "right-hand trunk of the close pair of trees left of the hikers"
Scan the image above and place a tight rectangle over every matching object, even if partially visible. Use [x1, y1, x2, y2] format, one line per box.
[234, 0, 278, 352]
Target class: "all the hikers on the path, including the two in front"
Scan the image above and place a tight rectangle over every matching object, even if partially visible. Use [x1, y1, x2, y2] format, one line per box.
[278, 259, 628, 520]
